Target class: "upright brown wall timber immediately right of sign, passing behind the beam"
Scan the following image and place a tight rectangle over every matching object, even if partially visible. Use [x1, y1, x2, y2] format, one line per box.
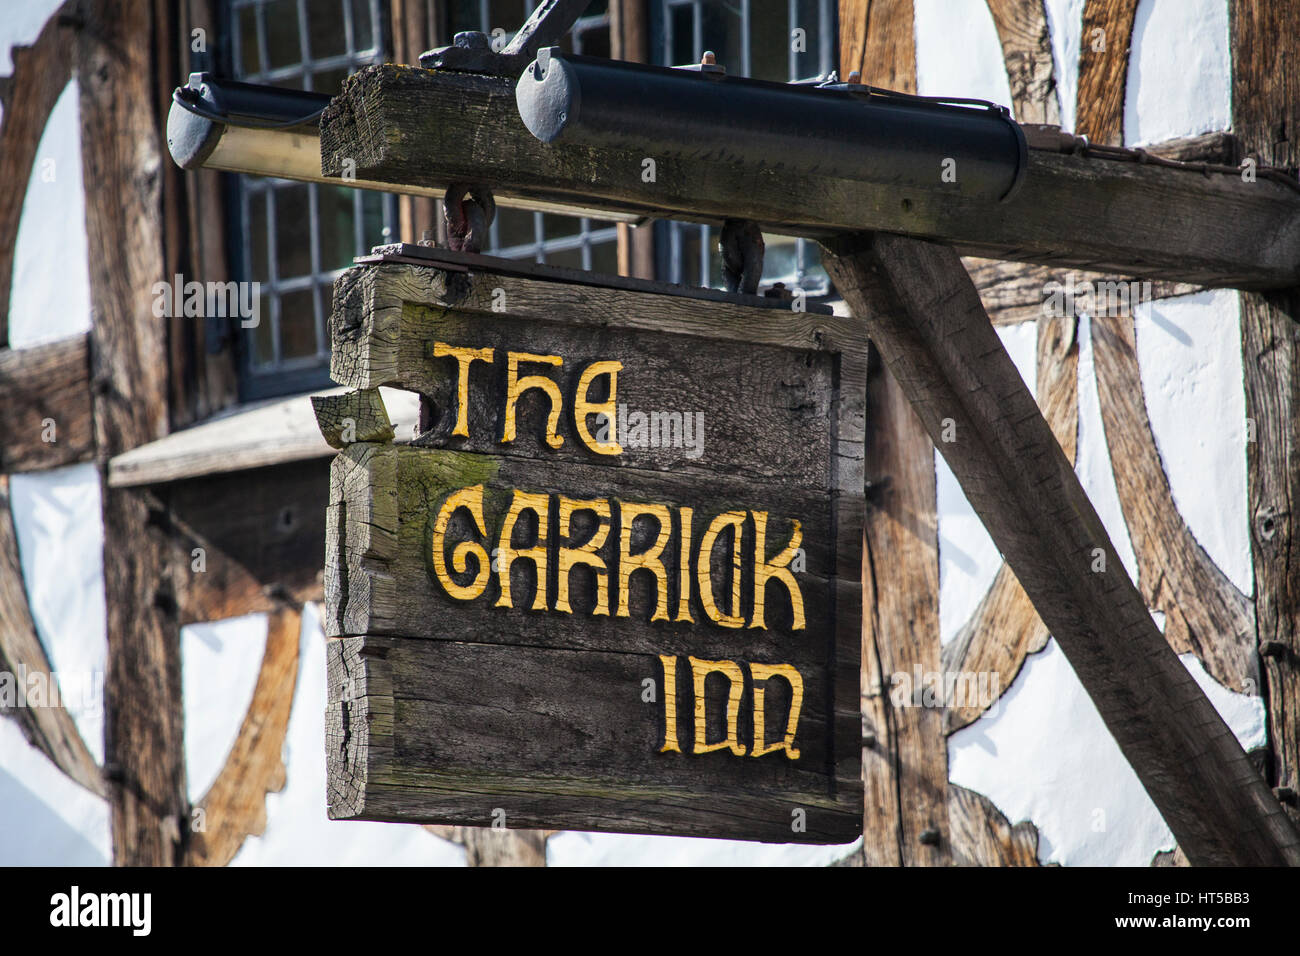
[840, 0, 959, 866]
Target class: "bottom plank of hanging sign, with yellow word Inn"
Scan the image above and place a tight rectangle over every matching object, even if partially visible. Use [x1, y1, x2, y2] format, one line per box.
[326, 636, 861, 843]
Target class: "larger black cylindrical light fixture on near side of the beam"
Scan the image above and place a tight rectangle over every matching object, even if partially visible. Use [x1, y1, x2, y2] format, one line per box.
[515, 47, 1028, 199]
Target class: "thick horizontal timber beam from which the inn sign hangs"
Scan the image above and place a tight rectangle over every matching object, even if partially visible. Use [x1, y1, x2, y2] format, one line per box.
[320, 64, 1300, 289]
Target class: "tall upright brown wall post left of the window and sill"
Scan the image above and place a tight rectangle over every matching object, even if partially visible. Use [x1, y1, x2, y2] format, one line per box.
[74, 0, 190, 866]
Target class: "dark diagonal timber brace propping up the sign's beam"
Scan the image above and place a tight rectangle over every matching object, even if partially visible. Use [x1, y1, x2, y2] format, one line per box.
[824, 234, 1300, 865]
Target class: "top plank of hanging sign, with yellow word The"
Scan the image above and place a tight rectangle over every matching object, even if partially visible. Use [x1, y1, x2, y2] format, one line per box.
[332, 264, 862, 492]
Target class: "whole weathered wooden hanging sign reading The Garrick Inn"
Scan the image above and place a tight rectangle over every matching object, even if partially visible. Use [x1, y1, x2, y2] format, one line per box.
[315, 254, 866, 843]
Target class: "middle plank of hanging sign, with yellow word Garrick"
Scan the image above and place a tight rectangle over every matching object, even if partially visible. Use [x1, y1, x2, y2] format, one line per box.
[326, 444, 857, 663]
